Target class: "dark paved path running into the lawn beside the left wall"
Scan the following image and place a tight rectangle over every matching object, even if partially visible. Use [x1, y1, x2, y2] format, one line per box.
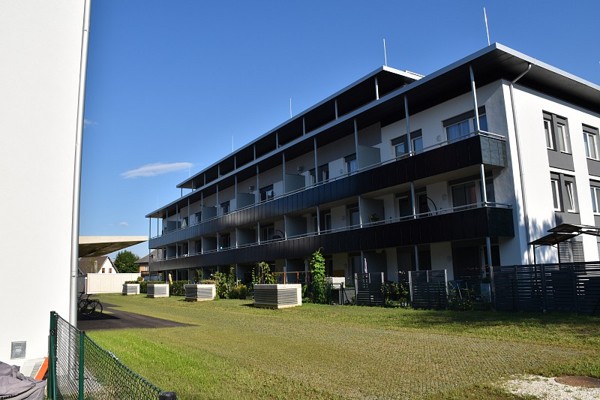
[77, 303, 188, 331]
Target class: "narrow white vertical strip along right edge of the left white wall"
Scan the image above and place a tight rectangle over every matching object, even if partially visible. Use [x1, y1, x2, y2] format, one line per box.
[69, 0, 91, 326]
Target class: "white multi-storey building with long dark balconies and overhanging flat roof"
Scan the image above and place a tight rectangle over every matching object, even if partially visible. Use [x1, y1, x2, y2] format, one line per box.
[147, 44, 600, 280]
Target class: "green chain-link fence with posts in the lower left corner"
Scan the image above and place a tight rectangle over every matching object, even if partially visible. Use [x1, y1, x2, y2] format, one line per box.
[48, 312, 176, 400]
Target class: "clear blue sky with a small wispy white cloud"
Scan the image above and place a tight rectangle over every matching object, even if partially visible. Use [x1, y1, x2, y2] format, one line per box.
[80, 0, 600, 256]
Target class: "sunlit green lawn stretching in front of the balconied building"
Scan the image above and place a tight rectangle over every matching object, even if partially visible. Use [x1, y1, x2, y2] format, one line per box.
[88, 295, 600, 399]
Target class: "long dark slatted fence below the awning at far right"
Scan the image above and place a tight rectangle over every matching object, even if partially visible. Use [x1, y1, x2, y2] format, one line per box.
[492, 262, 600, 315]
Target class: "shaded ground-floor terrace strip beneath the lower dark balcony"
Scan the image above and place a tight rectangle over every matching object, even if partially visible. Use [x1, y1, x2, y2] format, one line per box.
[150, 234, 502, 286]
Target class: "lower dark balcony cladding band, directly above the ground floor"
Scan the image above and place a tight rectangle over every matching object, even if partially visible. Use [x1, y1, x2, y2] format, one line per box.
[152, 207, 514, 270]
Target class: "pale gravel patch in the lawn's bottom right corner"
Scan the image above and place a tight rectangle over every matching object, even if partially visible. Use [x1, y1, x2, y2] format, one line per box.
[502, 375, 600, 400]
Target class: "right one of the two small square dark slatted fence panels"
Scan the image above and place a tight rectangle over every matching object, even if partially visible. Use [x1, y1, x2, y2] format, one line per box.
[408, 269, 448, 310]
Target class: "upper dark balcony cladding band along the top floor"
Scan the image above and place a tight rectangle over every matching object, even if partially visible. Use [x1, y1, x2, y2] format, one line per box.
[150, 136, 506, 248]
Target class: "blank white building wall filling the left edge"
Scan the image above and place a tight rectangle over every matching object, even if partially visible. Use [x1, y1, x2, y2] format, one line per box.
[0, 0, 88, 365]
